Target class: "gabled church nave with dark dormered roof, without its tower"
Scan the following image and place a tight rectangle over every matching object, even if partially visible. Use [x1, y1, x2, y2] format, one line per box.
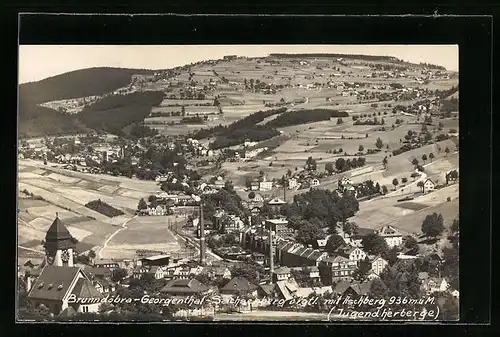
[28, 265, 103, 315]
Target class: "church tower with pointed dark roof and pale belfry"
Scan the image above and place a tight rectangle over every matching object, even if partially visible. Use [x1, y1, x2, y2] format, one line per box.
[44, 213, 77, 267]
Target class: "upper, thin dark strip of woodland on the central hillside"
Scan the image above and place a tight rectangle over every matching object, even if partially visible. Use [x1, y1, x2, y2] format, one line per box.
[266, 109, 349, 127]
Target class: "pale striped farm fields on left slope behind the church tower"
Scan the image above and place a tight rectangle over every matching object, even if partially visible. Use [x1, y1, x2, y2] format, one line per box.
[18, 160, 164, 255]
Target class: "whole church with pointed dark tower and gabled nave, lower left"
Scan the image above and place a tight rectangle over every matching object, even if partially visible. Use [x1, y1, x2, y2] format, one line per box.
[27, 216, 102, 315]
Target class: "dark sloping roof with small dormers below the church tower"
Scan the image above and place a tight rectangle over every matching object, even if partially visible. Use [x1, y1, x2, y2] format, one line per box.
[28, 265, 80, 301]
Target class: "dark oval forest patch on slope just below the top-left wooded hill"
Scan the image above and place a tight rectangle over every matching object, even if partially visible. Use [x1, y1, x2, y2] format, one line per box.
[78, 91, 163, 134]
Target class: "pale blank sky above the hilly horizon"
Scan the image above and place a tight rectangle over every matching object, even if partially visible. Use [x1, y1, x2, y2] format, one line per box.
[19, 45, 458, 83]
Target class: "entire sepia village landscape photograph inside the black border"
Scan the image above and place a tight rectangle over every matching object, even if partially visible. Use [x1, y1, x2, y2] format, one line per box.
[16, 44, 465, 323]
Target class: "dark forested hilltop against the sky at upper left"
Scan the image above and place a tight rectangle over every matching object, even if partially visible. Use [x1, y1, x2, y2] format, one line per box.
[19, 67, 154, 104]
